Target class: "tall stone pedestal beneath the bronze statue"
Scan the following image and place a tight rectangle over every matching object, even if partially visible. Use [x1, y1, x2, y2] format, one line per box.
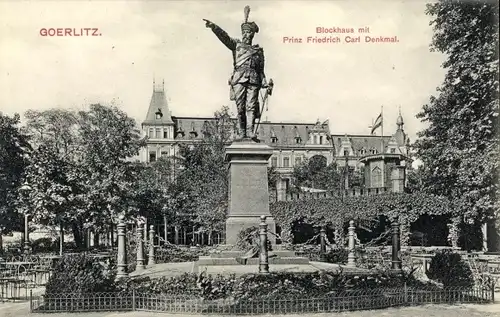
[226, 140, 276, 245]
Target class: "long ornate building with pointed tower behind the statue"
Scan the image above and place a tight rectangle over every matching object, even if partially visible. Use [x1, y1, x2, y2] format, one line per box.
[140, 85, 409, 199]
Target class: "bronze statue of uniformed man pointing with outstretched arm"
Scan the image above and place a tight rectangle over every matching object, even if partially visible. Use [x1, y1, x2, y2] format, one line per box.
[203, 6, 268, 140]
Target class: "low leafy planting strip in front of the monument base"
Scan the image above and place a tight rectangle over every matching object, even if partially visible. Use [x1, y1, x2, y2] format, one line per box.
[120, 272, 420, 300]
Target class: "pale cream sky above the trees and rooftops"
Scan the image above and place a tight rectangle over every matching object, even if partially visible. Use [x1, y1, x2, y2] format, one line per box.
[0, 0, 445, 140]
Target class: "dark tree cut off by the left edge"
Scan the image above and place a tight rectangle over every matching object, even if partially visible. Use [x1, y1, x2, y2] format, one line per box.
[0, 113, 30, 250]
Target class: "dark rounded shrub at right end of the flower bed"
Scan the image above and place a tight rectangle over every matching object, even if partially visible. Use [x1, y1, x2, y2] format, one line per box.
[427, 250, 474, 286]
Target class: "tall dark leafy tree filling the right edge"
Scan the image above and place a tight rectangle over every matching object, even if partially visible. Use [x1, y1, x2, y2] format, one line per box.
[415, 0, 500, 247]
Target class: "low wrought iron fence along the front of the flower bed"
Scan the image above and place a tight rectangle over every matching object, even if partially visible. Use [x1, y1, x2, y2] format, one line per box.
[30, 287, 494, 315]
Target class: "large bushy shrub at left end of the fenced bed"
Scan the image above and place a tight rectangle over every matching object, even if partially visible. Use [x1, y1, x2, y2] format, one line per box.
[45, 254, 116, 294]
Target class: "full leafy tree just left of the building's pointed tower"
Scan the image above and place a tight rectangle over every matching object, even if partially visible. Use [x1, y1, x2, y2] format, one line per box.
[78, 104, 145, 225]
